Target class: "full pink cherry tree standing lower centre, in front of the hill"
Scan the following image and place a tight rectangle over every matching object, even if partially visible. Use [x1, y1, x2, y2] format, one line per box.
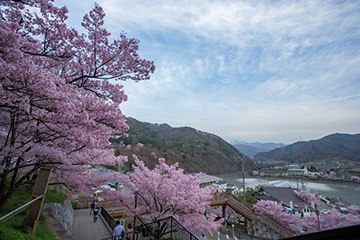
[107, 156, 222, 237]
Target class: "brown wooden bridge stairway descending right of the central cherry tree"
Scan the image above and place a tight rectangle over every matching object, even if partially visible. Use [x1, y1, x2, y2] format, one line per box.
[210, 194, 296, 238]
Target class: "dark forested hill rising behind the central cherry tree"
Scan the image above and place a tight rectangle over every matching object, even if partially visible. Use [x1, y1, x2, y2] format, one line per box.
[111, 118, 254, 174]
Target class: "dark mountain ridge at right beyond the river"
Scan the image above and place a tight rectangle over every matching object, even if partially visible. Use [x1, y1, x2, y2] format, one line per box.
[254, 133, 360, 163]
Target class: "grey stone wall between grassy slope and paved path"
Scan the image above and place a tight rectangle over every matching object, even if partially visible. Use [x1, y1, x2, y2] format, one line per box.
[46, 200, 74, 236]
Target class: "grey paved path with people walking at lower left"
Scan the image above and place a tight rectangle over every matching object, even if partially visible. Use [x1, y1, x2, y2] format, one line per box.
[72, 209, 111, 240]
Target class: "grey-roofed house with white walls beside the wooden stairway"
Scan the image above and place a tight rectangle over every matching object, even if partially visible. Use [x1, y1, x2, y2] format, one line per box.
[254, 186, 312, 216]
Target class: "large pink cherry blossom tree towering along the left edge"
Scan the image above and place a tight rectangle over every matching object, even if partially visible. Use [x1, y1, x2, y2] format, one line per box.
[0, 0, 154, 209]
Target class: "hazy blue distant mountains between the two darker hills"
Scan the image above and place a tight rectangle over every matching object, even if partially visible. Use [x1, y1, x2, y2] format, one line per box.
[233, 141, 285, 158]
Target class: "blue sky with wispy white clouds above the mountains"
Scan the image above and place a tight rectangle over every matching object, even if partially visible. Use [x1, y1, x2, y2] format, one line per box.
[55, 0, 360, 144]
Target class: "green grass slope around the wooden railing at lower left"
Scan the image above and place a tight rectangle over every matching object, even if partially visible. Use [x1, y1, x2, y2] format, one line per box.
[0, 187, 65, 240]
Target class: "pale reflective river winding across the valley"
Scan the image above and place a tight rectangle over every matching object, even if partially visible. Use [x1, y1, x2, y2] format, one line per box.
[218, 173, 360, 205]
